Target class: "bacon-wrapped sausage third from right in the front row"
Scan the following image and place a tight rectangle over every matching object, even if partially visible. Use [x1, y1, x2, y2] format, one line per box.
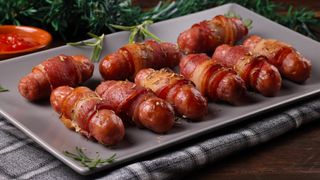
[180, 54, 246, 104]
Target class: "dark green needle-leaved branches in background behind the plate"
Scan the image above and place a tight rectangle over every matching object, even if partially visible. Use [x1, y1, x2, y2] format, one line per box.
[0, 0, 320, 40]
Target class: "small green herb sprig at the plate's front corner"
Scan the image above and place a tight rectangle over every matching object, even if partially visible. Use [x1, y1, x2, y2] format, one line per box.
[63, 146, 116, 169]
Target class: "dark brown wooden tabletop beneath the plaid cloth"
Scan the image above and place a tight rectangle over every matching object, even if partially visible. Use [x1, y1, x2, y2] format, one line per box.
[136, 0, 320, 180]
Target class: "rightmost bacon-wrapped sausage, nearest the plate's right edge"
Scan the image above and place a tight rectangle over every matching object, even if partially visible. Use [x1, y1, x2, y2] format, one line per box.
[243, 35, 311, 83]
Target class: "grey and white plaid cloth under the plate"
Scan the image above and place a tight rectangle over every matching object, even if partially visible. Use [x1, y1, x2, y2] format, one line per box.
[0, 96, 320, 180]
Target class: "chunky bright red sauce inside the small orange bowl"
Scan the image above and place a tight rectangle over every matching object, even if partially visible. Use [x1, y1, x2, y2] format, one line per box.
[0, 33, 38, 52]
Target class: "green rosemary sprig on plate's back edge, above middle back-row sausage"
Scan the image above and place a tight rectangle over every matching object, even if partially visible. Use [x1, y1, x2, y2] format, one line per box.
[110, 20, 161, 43]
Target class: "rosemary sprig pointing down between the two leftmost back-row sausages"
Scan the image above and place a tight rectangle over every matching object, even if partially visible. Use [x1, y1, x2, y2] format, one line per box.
[67, 32, 104, 62]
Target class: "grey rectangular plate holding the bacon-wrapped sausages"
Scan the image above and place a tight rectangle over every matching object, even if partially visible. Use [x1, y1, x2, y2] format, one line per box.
[0, 4, 320, 174]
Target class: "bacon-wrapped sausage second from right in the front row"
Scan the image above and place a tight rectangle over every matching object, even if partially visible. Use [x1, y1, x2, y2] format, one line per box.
[212, 45, 282, 96]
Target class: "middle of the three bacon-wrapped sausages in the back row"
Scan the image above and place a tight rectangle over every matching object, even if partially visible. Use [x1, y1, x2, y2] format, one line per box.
[99, 40, 181, 80]
